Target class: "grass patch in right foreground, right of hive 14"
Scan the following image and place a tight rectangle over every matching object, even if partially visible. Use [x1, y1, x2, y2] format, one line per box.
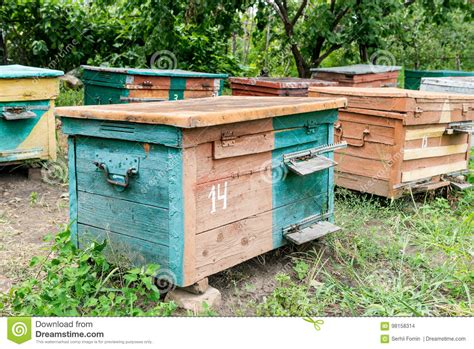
[256, 190, 474, 316]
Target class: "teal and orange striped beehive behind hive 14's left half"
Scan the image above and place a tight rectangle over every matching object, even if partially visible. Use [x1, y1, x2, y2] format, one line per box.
[83, 66, 227, 105]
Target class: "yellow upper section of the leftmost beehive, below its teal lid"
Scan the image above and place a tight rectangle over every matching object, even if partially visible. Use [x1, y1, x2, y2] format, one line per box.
[0, 78, 59, 102]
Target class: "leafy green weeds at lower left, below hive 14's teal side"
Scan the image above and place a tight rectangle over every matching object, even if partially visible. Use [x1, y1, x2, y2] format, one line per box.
[1, 230, 176, 316]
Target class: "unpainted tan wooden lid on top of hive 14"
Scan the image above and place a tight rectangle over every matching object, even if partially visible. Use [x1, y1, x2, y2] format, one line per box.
[56, 96, 347, 128]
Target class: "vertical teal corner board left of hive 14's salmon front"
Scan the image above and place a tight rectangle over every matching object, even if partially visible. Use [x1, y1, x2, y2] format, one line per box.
[167, 144, 184, 286]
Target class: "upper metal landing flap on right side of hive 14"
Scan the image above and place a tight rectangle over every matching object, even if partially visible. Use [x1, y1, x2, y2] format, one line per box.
[283, 141, 347, 176]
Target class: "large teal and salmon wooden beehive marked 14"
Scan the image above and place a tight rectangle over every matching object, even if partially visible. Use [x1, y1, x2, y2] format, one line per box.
[56, 96, 345, 286]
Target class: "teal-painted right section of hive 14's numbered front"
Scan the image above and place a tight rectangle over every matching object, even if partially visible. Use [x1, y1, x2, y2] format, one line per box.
[272, 110, 337, 248]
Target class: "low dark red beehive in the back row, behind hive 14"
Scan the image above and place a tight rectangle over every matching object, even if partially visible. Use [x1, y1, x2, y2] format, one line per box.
[229, 77, 337, 97]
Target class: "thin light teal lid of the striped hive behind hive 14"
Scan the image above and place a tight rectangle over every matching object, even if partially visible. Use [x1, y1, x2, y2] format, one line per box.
[81, 65, 228, 79]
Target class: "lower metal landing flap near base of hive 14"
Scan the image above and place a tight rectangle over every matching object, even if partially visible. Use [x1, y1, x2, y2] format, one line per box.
[283, 214, 341, 245]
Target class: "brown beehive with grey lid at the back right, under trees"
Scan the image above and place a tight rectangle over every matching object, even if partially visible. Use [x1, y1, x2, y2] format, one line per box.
[311, 64, 401, 87]
